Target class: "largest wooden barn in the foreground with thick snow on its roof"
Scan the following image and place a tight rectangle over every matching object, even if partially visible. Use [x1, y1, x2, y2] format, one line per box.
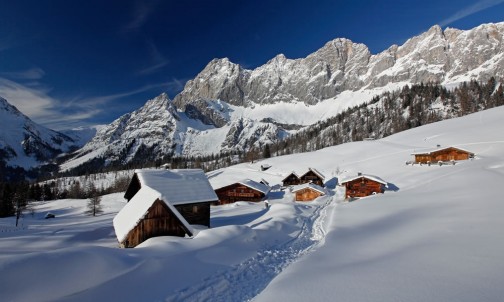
[113, 169, 218, 247]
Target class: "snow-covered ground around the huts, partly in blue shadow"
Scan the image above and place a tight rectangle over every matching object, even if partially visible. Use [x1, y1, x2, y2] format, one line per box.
[0, 107, 504, 301]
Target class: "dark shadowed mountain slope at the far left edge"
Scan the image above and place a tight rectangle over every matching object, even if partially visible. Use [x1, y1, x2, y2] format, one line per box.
[0, 97, 77, 168]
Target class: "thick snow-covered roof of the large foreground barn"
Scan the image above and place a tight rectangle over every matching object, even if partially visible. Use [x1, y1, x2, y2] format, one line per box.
[113, 169, 218, 242]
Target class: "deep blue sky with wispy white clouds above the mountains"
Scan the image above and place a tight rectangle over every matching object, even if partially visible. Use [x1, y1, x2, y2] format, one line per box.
[0, 0, 504, 131]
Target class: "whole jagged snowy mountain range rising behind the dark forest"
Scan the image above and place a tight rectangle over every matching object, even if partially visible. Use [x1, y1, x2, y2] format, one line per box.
[0, 23, 504, 178]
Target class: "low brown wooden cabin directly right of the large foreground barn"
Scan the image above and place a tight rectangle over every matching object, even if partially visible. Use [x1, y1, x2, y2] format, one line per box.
[215, 179, 270, 204]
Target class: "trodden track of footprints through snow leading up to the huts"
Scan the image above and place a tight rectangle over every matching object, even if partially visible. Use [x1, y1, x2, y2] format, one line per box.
[165, 195, 336, 301]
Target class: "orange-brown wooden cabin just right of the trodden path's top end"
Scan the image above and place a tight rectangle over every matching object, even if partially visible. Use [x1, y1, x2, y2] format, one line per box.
[341, 173, 387, 198]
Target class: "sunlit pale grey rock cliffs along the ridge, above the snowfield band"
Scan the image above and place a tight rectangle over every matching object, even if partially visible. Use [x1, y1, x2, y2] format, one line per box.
[174, 23, 504, 109]
